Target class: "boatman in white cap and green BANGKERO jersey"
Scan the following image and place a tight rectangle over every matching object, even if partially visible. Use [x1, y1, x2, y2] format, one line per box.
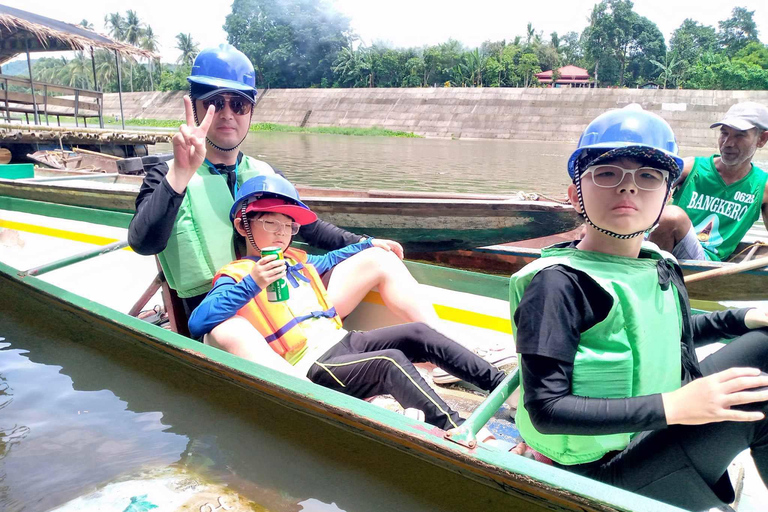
[650, 102, 768, 261]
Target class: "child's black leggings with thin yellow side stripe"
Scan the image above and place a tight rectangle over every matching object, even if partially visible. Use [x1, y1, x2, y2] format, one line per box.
[307, 323, 504, 429]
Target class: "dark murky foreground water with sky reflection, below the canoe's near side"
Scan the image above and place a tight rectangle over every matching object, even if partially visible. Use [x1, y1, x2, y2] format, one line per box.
[0, 294, 537, 512]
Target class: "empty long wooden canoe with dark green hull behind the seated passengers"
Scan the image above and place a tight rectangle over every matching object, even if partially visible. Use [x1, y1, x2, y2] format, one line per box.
[0, 168, 580, 252]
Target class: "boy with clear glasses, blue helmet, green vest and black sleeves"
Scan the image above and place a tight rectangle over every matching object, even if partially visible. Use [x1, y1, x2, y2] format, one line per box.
[510, 105, 768, 510]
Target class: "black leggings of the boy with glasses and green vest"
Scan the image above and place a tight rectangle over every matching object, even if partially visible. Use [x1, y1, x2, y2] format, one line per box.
[558, 329, 768, 510]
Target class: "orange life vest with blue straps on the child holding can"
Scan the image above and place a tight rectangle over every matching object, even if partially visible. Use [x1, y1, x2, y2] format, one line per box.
[213, 247, 342, 364]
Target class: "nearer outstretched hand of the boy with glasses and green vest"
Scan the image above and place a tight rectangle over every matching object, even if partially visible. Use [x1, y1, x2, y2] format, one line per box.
[661, 368, 768, 425]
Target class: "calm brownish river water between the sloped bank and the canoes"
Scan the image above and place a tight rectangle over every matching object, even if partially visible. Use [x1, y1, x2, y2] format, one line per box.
[151, 132, 768, 195]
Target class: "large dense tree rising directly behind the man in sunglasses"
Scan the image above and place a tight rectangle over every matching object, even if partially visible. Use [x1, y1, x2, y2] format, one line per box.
[224, 0, 350, 87]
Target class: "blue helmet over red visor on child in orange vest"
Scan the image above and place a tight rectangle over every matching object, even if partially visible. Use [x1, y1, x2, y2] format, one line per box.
[229, 174, 317, 226]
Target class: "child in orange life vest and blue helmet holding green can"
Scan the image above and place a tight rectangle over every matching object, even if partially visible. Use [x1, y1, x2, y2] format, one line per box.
[189, 175, 504, 429]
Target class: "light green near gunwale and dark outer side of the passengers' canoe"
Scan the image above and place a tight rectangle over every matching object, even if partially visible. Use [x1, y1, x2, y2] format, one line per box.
[0, 263, 681, 512]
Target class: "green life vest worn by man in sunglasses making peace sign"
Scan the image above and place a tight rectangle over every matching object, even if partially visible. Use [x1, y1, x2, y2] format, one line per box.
[157, 156, 275, 298]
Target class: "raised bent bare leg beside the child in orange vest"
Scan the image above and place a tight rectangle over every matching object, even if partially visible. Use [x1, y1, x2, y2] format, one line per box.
[328, 247, 438, 325]
